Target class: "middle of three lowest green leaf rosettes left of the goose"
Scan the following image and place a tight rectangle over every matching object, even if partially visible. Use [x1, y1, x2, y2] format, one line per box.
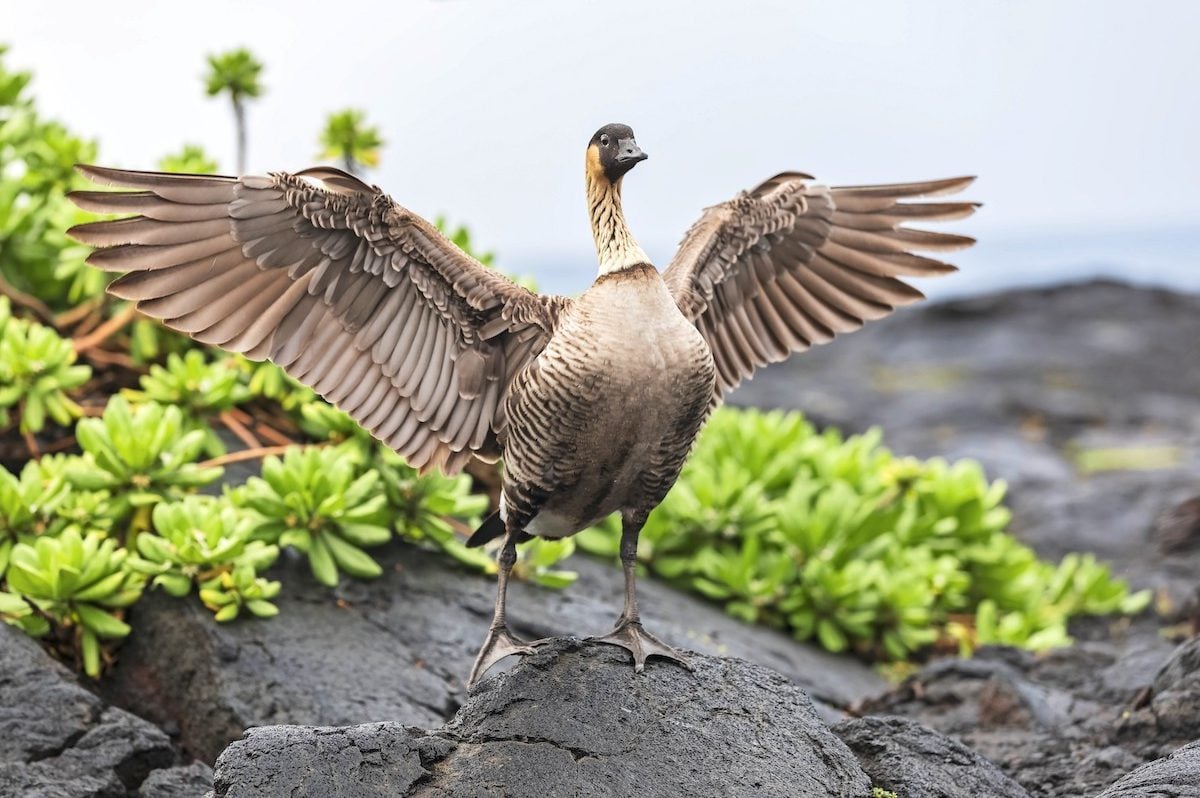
[130, 496, 280, 622]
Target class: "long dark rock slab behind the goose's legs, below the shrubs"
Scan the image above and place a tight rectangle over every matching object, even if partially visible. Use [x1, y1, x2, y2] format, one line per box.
[102, 542, 886, 762]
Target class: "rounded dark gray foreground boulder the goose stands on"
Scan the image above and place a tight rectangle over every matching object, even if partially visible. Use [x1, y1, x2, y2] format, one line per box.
[215, 640, 871, 798]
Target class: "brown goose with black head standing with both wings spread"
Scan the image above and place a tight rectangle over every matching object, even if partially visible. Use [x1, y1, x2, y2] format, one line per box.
[70, 124, 977, 685]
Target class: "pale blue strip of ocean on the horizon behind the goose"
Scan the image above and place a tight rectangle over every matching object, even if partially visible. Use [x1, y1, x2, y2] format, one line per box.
[518, 226, 1200, 299]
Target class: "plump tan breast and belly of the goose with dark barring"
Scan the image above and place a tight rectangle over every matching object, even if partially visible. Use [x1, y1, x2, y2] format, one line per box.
[505, 275, 714, 538]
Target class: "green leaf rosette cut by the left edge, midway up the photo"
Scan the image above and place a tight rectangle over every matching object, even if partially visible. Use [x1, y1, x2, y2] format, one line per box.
[0, 296, 91, 433]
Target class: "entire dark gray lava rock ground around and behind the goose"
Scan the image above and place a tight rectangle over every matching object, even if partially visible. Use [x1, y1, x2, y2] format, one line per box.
[0, 283, 1200, 798]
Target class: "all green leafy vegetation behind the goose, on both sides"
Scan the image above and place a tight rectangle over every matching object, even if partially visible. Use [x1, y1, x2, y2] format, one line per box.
[0, 49, 1148, 677]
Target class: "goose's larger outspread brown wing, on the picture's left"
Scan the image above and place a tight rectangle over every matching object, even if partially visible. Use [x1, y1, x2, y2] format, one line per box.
[71, 167, 569, 473]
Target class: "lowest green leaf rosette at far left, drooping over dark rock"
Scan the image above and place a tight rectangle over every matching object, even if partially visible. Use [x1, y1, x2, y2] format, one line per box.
[7, 529, 144, 678]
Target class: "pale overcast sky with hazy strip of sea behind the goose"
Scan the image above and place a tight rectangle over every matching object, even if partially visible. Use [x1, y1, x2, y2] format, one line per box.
[0, 0, 1200, 293]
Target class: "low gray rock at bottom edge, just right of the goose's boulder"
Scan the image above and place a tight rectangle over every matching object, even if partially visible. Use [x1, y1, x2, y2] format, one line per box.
[833, 718, 1030, 798]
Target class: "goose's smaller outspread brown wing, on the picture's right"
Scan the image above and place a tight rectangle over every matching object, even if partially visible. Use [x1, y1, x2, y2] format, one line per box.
[664, 173, 978, 402]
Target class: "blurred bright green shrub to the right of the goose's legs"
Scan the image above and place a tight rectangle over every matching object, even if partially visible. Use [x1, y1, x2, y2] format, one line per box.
[580, 408, 1148, 660]
